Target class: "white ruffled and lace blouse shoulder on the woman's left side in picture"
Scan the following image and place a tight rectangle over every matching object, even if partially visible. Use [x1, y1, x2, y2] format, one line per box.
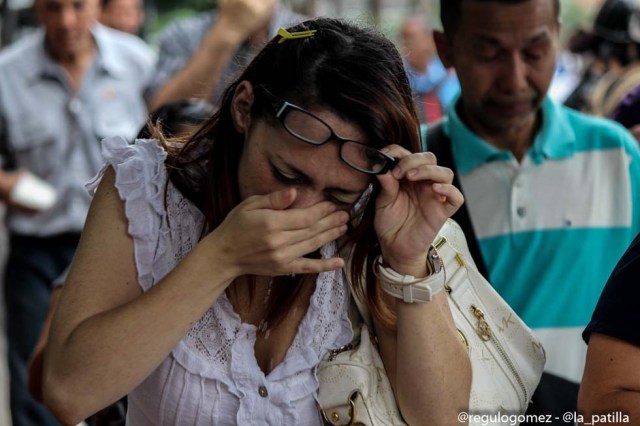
[95, 137, 203, 291]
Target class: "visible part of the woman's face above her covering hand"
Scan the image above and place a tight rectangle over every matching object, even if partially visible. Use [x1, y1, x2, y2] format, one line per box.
[238, 108, 374, 211]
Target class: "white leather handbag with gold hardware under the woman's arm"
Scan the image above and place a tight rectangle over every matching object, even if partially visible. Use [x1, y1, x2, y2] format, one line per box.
[316, 220, 546, 426]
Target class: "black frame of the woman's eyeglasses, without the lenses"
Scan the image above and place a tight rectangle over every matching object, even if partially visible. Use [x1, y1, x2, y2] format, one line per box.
[258, 86, 398, 175]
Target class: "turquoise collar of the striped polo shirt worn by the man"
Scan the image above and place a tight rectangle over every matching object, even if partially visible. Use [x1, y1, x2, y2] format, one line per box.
[444, 95, 576, 174]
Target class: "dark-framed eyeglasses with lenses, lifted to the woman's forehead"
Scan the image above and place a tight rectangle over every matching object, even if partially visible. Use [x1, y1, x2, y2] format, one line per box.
[258, 86, 397, 175]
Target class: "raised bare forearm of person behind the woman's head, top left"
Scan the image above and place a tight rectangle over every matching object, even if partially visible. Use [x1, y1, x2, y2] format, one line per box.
[149, 0, 277, 111]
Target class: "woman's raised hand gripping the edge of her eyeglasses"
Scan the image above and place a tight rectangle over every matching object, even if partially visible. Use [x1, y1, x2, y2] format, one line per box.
[375, 145, 464, 273]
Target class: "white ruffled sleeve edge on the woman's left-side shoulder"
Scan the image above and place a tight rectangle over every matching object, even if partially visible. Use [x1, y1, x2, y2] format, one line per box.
[86, 137, 167, 291]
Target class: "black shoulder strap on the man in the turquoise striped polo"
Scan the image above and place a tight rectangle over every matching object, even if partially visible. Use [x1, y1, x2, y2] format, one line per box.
[423, 121, 489, 280]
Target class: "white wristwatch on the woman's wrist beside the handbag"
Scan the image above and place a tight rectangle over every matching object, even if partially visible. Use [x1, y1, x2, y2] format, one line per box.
[374, 246, 446, 303]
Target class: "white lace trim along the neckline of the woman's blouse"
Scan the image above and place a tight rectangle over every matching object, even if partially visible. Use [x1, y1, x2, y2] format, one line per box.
[173, 244, 353, 382]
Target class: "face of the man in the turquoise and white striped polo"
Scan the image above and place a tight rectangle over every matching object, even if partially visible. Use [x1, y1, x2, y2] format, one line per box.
[438, 0, 559, 135]
